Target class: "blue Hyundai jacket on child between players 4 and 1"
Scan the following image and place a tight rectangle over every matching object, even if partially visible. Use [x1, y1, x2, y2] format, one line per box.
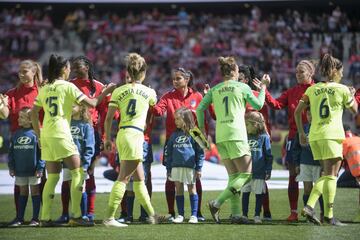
[165, 129, 205, 173]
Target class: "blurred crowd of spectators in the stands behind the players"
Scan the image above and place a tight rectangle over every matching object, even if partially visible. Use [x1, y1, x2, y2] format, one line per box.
[0, 6, 360, 135]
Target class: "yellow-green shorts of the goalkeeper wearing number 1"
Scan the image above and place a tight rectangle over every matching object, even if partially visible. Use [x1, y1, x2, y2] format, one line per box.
[216, 141, 251, 159]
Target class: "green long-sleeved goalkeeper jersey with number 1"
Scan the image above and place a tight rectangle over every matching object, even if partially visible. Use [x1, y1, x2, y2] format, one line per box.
[196, 80, 265, 143]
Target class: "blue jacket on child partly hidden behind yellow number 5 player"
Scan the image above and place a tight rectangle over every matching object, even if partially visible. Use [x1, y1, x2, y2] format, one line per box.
[70, 120, 95, 170]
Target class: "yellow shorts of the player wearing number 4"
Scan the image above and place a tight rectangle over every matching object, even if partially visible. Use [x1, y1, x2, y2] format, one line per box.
[116, 128, 144, 161]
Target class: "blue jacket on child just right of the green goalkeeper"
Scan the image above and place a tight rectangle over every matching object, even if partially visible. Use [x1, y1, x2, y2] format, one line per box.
[248, 134, 273, 179]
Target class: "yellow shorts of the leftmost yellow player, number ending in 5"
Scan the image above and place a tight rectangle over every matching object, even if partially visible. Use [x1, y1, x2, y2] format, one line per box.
[40, 137, 79, 162]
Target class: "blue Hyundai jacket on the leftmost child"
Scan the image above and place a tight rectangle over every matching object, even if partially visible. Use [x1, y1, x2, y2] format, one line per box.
[8, 128, 45, 177]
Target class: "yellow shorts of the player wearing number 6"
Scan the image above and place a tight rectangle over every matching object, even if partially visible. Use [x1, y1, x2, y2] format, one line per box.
[310, 139, 343, 160]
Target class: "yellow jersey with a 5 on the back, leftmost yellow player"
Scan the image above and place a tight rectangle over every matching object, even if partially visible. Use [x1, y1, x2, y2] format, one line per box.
[34, 80, 86, 139]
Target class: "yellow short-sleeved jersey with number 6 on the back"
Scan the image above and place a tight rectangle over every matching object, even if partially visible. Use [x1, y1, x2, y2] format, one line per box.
[304, 82, 354, 141]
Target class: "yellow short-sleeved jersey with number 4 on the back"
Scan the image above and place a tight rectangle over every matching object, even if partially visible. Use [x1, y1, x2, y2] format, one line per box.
[109, 83, 156, 131]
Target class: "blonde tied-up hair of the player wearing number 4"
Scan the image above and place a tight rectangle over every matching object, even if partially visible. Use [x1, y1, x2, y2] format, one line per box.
[125, 53, 147, 82]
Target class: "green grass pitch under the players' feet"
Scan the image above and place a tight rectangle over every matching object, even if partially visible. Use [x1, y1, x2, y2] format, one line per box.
[0, 189, 360, 240]
